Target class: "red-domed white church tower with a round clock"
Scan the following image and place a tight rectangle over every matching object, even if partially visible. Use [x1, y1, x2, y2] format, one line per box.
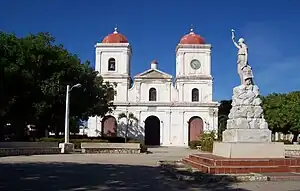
[175, 28, 213, 102]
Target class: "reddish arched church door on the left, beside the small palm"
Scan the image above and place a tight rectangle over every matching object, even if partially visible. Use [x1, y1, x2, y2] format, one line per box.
[102, 115, 117, 137]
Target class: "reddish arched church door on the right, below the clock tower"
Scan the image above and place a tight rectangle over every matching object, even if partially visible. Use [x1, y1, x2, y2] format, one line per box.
[188, 116, 203, 143]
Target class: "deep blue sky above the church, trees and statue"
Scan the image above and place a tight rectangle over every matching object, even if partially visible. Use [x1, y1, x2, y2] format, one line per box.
[0, 0, 300, 100]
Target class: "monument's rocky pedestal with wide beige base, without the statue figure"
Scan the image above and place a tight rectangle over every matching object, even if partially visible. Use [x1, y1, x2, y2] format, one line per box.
[213, 84, 285, 159]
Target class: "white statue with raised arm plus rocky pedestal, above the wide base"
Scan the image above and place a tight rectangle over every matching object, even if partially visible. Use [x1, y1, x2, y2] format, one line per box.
[223, 29, 271, 142]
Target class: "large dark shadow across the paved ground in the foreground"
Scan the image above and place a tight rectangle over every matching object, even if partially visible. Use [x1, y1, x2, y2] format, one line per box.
[0, 163, 246, 191]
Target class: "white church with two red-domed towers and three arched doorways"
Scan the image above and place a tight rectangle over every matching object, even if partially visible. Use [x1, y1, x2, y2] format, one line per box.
[85, 28, 219, 147]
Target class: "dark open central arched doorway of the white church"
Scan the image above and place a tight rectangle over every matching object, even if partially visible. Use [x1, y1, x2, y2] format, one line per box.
[145, 115, 160, 145]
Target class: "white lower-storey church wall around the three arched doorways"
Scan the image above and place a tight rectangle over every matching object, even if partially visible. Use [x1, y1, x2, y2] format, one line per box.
[85, 107, 218, 147]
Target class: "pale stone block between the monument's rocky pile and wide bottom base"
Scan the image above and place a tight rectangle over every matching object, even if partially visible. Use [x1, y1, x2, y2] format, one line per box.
[222, 129, 272, 143]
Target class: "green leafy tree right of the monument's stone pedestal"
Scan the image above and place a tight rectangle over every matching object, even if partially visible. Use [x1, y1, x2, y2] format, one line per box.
[262, 91, 300, 142]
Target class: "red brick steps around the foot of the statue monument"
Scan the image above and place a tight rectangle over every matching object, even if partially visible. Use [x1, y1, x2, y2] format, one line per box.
[183, 154, 300, 174]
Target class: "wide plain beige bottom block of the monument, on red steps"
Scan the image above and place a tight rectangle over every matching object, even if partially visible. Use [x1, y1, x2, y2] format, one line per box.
[213, 142, 285, 158]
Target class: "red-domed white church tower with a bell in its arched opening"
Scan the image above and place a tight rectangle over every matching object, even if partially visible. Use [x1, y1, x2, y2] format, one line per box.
[95, 28, 132, 102]
